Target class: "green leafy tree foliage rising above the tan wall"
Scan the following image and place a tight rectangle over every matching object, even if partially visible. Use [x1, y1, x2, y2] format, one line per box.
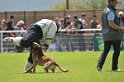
[51, 0, 108, 10]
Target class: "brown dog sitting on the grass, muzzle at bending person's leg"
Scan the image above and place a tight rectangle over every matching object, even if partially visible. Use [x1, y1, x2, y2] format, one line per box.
[29, 42, 69, 73]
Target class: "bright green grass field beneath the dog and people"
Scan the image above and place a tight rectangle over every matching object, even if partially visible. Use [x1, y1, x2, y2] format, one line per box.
[0, 52, 124, 82]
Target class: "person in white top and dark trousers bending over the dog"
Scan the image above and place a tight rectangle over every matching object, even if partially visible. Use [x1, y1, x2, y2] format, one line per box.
[3, 19, 57, 73]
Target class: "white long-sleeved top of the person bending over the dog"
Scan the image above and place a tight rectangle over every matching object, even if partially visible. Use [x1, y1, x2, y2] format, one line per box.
[34, 19, 57, 45]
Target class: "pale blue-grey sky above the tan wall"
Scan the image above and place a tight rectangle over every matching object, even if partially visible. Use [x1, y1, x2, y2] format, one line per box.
[0, 0, 124, 12]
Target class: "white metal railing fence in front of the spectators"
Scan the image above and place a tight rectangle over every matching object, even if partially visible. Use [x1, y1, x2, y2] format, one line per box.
[0, 29, 101, 52]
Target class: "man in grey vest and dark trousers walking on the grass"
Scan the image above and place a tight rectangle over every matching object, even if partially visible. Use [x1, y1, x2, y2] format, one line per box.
[97, 0, 124, 71]
